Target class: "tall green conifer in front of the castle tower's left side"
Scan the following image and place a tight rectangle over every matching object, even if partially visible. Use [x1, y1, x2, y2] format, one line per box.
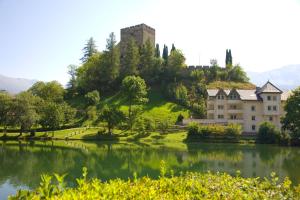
[122, 38, 140, 77]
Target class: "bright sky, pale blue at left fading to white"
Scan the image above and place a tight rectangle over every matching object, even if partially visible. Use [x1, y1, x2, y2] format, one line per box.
[0, 0, 300, 84]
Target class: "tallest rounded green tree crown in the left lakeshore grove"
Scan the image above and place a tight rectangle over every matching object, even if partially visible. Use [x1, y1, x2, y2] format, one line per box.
[29, 81, 65, 103]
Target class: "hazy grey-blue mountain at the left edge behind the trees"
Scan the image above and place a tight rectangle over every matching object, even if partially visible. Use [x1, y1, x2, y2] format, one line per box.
[0, 75, 36, 94]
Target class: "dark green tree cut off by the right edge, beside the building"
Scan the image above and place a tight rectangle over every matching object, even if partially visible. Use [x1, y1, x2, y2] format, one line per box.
[282, 87, 300, 138]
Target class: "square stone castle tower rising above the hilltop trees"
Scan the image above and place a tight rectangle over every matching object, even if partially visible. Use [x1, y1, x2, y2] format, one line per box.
[120, 24, 155, 57]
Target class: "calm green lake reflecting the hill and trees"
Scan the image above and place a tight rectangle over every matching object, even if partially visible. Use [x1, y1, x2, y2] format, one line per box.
[0, 141, 300, 199]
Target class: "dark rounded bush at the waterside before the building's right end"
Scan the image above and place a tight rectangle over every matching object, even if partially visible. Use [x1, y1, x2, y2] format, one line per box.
[257, 122, 281, 144]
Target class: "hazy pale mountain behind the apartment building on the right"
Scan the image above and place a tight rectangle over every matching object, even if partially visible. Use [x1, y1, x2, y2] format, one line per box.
[247, 64, 300, 90]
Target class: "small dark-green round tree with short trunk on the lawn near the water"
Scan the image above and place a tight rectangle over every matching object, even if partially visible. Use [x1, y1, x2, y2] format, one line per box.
[101, 106, 125, 134]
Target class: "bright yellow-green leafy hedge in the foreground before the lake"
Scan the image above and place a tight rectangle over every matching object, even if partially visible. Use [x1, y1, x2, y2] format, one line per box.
[10, 166, 300, 200]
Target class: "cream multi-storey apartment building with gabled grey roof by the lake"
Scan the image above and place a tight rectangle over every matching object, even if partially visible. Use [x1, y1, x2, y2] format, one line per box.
[206, 81, 290, 133]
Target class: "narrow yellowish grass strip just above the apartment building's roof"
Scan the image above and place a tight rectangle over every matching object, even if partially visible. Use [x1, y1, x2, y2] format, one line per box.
[207, 81, 256, 90]
